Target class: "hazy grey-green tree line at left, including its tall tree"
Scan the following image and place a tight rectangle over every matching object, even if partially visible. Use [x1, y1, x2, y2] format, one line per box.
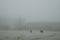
[0, 17, 24, 30]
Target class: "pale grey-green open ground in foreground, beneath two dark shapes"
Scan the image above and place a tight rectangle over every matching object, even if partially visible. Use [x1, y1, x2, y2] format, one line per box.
[0, 30, 60, 40]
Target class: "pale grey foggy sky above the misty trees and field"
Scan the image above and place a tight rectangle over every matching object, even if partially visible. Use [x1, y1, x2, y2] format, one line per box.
[0, 0, 60, 22]
